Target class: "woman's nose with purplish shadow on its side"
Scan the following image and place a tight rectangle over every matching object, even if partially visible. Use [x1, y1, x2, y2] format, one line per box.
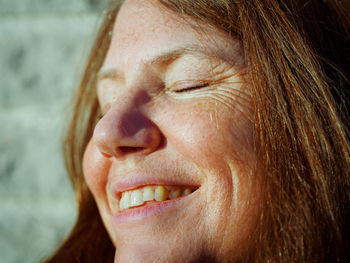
[93, 93, 162, 158]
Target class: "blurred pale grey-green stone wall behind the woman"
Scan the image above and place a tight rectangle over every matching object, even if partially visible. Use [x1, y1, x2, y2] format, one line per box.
[0, 0, 107, 263]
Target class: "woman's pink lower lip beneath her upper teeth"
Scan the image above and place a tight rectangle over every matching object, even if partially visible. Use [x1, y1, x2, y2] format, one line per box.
[113, 189, 199, 224]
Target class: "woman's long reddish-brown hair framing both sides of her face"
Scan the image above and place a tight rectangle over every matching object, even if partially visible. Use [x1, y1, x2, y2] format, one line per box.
[47, 0, 350, 262]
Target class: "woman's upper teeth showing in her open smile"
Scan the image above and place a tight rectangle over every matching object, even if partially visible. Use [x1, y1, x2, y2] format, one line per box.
[119, 185, 192, 210]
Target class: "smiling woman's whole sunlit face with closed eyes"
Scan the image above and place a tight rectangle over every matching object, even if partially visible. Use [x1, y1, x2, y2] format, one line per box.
[83, 0, 260, 262]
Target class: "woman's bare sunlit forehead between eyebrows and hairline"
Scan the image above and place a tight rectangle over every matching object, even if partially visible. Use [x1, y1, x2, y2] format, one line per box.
[105, 0, 238, 69]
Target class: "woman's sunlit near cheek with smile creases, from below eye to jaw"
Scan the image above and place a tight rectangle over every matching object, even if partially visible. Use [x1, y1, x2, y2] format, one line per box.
[159, 99, 259, 252]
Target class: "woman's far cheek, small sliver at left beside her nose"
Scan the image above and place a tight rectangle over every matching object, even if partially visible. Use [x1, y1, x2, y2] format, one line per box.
[83, 141, 111, 199]
